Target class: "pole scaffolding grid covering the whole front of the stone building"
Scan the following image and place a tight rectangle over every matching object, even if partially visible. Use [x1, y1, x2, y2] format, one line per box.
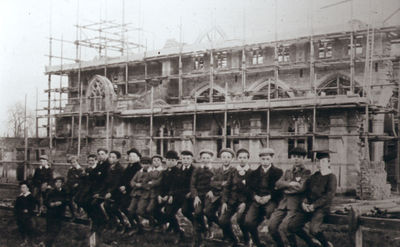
[42, 1, 400, 172]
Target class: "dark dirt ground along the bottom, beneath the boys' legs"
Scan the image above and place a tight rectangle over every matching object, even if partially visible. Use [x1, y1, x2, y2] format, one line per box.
[0, 210, 400, 247]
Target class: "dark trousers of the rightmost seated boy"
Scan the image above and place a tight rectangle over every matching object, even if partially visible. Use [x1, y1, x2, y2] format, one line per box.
[287, 208, 329, 247]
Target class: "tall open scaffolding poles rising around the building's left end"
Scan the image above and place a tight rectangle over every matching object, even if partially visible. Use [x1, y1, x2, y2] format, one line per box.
[36, 1, 146, 155]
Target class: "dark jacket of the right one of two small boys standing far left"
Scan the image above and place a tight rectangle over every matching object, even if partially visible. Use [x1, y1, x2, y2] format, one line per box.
[44, 188, 68, 219]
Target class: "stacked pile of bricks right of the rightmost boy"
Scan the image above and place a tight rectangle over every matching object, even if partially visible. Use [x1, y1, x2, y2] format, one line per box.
[357, 160, 391, 200]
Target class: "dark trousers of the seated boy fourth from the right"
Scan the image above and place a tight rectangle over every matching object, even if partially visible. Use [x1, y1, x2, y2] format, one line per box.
[218, 202, 250, 243]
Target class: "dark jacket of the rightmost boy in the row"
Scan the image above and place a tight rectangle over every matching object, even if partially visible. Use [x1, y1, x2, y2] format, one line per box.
[305, 171, 337, 208]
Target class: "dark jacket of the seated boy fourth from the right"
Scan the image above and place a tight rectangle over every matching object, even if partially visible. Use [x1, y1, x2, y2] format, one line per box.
[222, 169, 251, 205]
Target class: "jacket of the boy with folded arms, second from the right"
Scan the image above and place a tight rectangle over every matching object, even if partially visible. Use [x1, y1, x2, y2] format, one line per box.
[275, 165, 311, 210]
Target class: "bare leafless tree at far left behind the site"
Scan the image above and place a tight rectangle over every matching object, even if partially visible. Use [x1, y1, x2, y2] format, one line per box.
[7, 102, 35, 137]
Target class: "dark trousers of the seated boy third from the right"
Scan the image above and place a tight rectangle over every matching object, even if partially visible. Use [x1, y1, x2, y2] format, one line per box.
[244, 201, 277, 245]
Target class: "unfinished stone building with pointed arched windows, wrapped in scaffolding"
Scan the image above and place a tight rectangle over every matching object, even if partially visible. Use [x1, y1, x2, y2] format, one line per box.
[41, 20, 400, 195]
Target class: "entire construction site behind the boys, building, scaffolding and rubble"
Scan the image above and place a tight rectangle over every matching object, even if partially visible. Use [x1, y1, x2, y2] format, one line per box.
[0, 1, 400, 246]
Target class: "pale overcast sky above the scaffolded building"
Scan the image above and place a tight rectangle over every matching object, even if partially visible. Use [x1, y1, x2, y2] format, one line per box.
[0, 0, 400, 136]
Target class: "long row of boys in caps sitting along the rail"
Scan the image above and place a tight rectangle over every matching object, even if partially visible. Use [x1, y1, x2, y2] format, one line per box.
[16, 147, 336, 247]
